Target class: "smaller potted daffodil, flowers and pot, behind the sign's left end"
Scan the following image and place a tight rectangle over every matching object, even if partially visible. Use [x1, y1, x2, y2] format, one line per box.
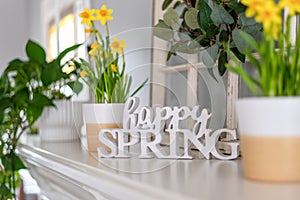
[76, 5, 147, 151]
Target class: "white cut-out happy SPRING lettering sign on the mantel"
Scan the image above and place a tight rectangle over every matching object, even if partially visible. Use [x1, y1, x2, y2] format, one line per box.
[98, 97, 239, 160]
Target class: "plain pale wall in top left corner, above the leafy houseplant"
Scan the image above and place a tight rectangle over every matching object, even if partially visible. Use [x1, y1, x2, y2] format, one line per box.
[0, 0, 42, 72]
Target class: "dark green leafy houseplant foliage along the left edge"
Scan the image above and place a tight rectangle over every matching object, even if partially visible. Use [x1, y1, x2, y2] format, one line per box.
[0, 40, 82, 199]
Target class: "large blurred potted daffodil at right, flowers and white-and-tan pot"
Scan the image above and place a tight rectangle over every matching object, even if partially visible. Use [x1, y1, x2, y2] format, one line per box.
[227, 0, 300, 182]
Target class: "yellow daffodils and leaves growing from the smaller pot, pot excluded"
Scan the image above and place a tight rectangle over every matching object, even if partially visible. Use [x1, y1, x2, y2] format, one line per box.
[77, 5, 147, 103]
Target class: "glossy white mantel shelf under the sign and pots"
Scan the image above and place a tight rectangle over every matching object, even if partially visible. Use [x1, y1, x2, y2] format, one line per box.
[19, 138, 300, 200]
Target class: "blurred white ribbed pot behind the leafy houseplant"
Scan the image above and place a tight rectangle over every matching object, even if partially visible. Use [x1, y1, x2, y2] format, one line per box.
[36, 100, 83, 142]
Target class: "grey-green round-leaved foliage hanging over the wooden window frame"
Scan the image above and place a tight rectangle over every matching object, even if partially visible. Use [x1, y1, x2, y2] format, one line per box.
[154, 0, 261, 75]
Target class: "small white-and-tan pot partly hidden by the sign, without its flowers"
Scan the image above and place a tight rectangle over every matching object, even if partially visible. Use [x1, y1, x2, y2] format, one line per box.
[82, 103, 125, 151]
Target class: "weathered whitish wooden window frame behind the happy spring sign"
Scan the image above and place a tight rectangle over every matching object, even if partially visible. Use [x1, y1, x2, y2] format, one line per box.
[151, 0, 239, 134]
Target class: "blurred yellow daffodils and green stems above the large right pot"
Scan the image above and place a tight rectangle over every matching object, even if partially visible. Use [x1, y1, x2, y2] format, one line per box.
[227, 0, 300, 96]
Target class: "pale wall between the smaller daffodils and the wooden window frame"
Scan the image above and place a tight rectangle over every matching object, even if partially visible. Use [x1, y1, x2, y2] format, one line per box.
[91, 0, 152, 105]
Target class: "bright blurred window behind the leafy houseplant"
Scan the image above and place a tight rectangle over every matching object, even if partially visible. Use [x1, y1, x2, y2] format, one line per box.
[41, 0, 90, 101]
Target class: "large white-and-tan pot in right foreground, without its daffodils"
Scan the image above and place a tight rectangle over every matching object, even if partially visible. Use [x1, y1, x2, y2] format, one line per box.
[236, 97, 300, 182]
